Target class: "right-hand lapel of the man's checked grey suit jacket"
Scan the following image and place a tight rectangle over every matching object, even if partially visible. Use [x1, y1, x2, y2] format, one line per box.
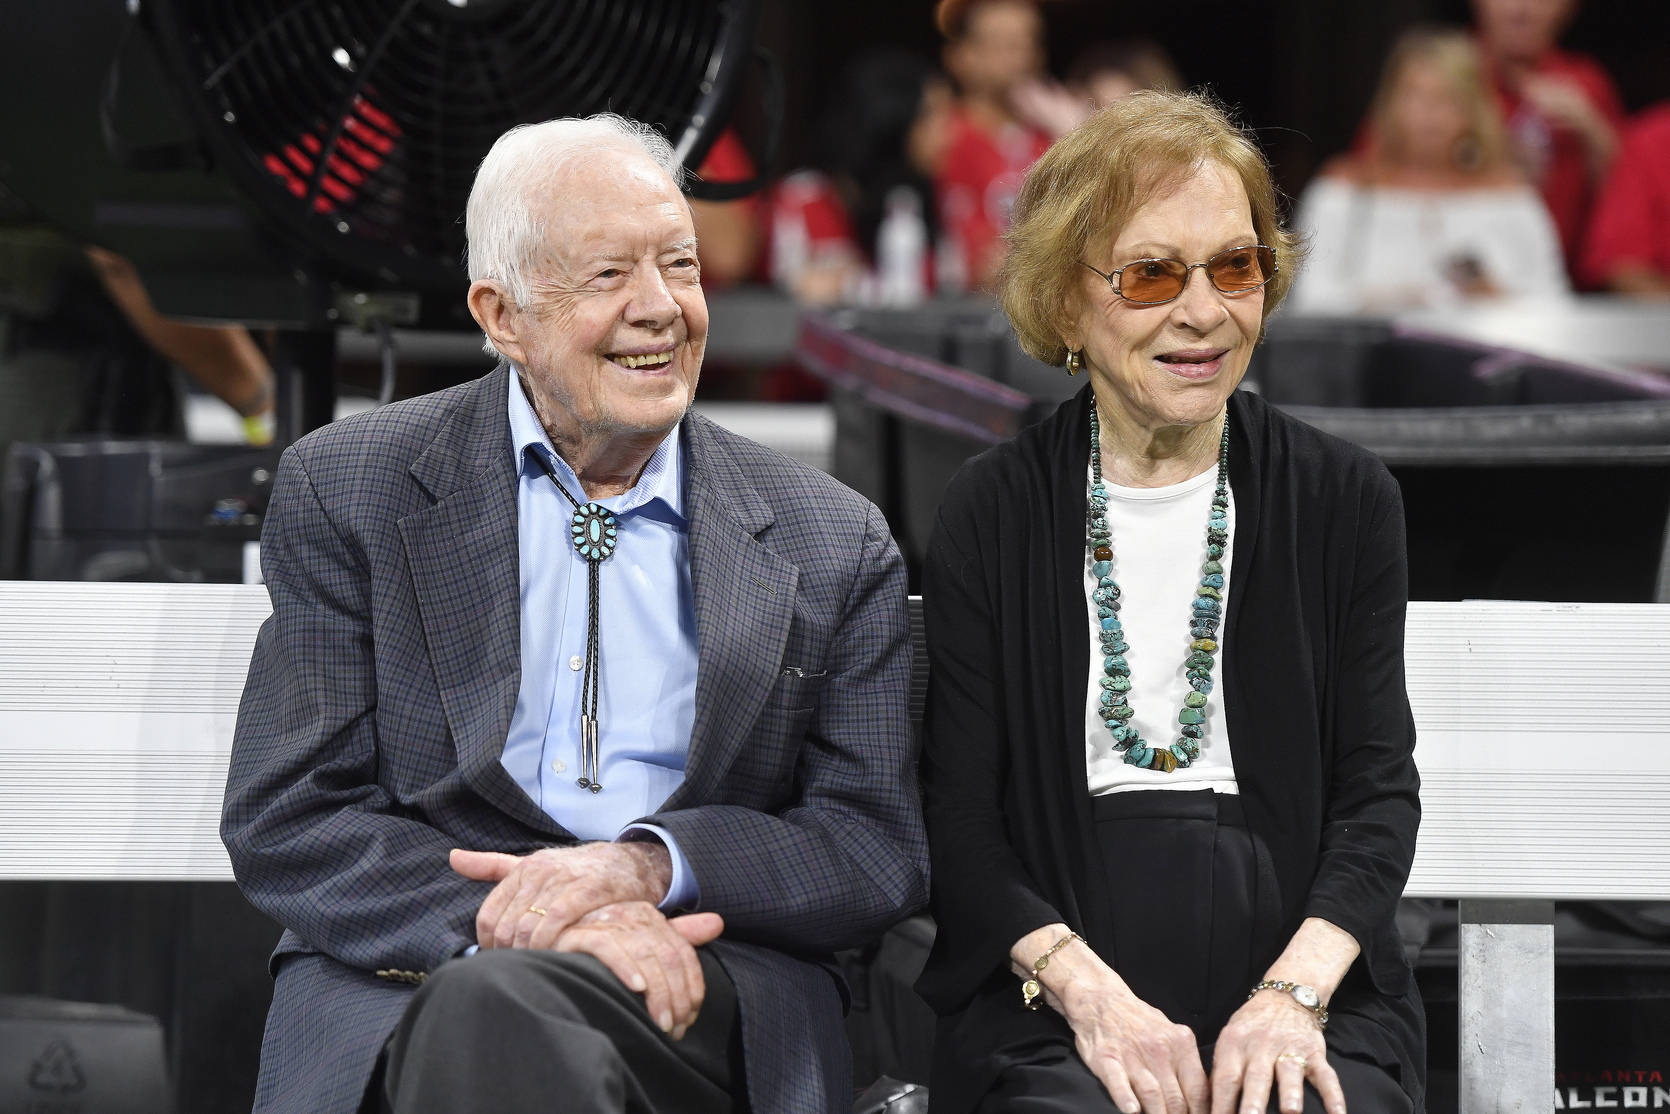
[665, 414, 800, 808]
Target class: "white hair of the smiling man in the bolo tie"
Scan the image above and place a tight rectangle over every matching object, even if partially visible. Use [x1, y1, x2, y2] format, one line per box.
[464, 112, 685, 330]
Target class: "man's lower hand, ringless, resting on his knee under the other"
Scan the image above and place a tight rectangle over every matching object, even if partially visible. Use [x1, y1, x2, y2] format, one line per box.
[556, 902, 725, 1041]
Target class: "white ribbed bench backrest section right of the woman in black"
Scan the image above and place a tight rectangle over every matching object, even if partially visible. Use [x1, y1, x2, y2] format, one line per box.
[1404, 601, 1670, 900]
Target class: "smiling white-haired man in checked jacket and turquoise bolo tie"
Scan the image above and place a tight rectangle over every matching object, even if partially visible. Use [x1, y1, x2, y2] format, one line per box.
[222, 117, 927, 1114]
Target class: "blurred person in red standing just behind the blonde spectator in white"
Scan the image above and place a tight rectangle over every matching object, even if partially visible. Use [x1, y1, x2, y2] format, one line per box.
[1473, 0, 1623, 271]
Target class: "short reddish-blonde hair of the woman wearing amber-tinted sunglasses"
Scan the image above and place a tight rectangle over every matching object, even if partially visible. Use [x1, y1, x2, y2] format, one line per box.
[997, 90, 1299, 366]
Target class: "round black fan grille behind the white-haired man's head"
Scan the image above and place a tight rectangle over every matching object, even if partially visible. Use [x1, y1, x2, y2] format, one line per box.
[161, 0, 726, 287]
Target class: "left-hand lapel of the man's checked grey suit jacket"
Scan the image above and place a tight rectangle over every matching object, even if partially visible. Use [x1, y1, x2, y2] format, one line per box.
[399, 367, 563, 833]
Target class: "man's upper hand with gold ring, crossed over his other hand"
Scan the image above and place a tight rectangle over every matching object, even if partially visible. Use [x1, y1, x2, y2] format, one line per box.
[451, 842, 673, 949]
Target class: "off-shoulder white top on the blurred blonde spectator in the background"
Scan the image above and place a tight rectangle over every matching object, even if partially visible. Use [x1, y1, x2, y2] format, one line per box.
[1288, 179, 1570, 314]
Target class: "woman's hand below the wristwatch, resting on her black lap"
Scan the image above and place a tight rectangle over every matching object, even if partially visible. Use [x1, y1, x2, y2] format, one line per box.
[1212, 990, 1346, 1114]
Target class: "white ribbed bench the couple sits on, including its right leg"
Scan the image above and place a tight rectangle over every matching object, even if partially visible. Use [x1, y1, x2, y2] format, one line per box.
[0, 581, 1670, 1114]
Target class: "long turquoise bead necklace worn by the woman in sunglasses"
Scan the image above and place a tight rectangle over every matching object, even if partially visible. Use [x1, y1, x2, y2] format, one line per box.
[1086, 394, 1229, 773]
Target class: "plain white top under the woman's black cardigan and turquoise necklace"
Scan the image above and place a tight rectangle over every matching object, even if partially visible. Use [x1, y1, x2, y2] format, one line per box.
[1084, 464, 1239, 797]
